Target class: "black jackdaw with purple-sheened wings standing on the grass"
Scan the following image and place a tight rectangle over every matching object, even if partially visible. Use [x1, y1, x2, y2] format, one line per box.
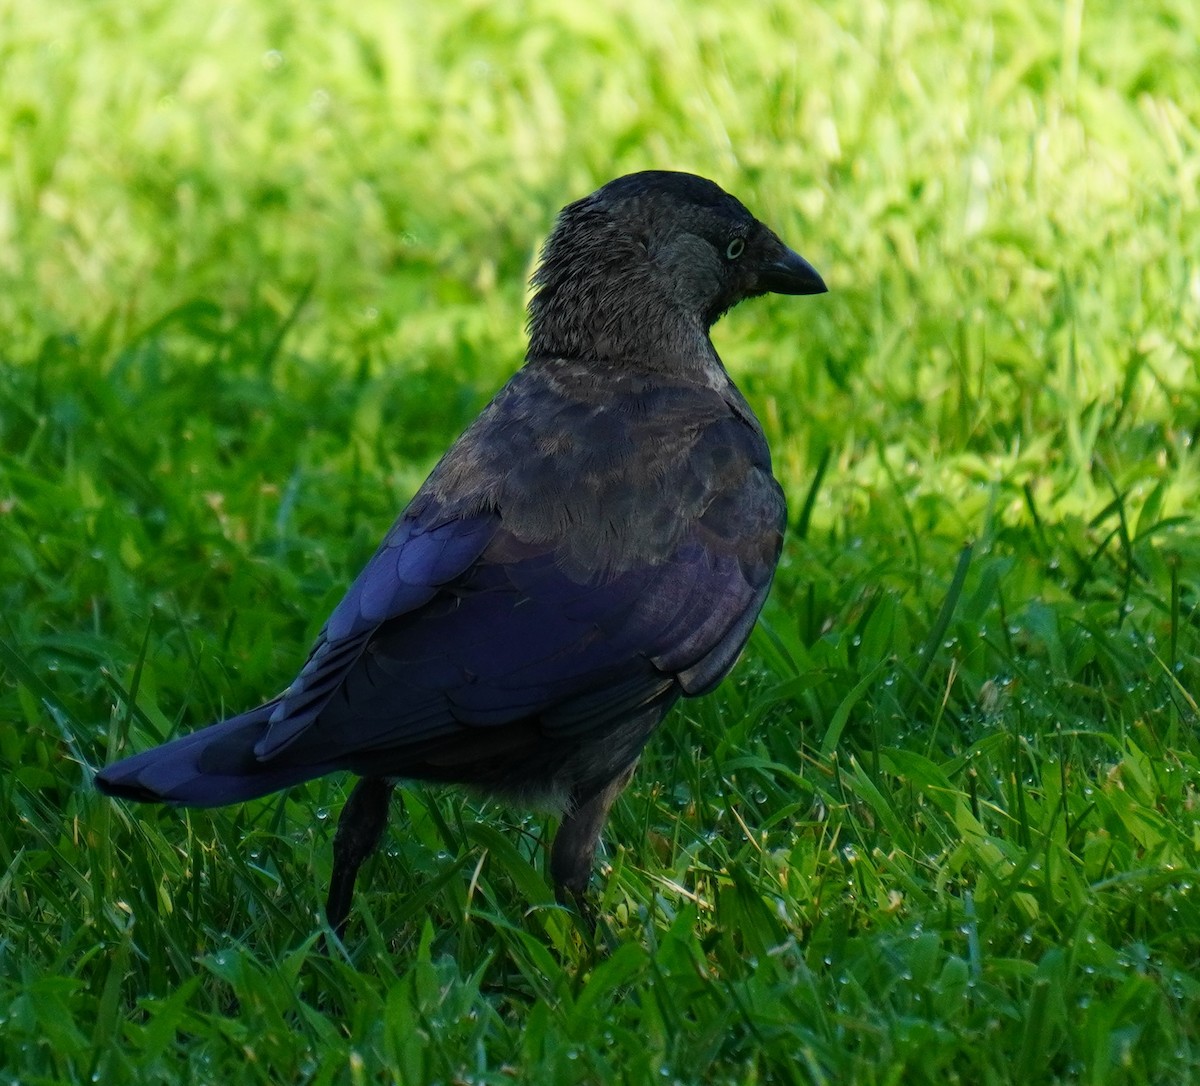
[96, 170, 826, 934]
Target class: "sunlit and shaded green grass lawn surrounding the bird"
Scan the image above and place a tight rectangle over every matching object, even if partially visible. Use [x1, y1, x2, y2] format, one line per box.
[0, 0, 1200, 1086]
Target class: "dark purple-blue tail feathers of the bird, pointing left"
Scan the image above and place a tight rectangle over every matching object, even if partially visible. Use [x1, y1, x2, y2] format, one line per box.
[96, 702, 336, 806]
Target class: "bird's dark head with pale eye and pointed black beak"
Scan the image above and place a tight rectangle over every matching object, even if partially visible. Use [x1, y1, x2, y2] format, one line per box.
[530, 170, 827, 354]
